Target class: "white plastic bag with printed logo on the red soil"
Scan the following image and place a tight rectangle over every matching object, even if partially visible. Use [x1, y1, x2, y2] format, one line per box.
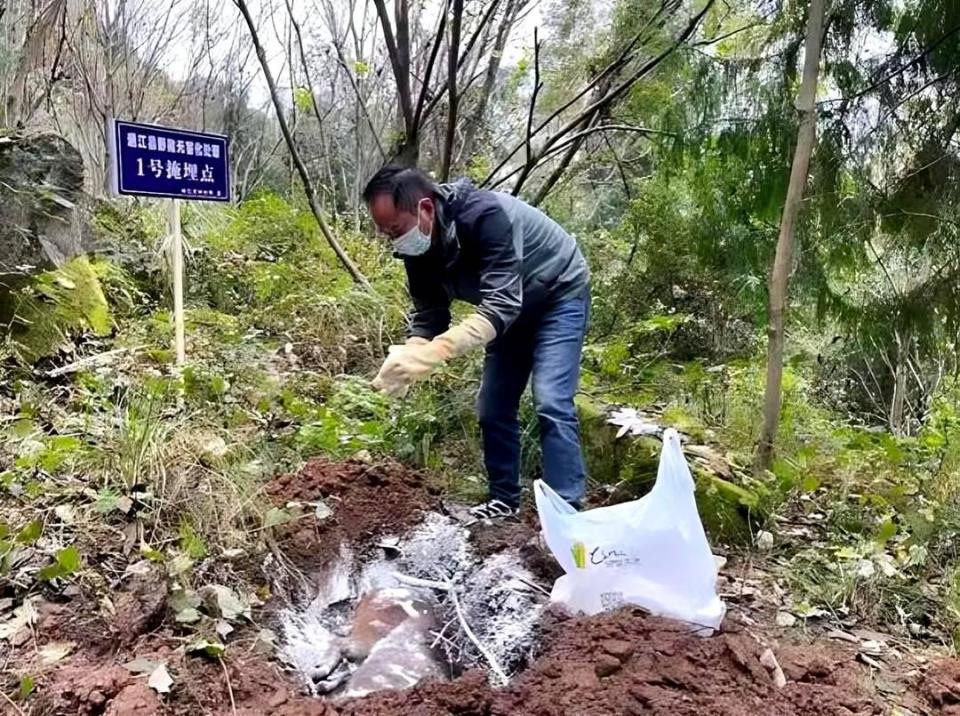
[534, 429, 725, 629]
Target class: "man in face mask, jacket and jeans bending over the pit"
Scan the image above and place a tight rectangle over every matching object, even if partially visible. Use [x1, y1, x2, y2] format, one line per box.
[363, 166, 590, 520]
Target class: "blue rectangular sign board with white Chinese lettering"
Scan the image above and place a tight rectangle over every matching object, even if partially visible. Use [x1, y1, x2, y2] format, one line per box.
[110, 119, 230, 201]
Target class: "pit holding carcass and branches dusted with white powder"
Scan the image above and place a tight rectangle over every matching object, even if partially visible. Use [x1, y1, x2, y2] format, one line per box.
[278, 512, 548, 701]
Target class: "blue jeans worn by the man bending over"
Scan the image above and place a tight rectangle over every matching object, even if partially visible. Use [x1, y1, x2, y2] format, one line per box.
[477, 291, 590, 508]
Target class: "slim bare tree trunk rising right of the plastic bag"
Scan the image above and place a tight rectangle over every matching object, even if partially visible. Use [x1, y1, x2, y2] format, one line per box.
[754, 0, 825, 472]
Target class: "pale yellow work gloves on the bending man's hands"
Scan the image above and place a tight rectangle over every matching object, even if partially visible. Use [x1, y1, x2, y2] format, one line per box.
[373, 313, 497, 398]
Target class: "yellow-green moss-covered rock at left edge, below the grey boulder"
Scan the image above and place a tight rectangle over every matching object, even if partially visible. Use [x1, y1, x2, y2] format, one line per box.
[0, 256, 113, 364]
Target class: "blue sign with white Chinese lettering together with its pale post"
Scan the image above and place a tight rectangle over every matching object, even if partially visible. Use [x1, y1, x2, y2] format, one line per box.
[108, 119, 230, 365]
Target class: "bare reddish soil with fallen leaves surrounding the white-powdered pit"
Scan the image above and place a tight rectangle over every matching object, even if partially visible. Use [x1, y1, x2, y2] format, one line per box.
[7, 461, 960, 716]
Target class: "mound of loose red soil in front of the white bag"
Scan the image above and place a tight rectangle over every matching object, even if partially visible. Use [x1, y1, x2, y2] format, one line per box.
[340, 611, 882, 716]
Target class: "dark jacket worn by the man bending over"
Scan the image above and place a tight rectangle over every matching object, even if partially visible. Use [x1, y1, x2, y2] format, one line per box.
[404, 180, 590, 338]
